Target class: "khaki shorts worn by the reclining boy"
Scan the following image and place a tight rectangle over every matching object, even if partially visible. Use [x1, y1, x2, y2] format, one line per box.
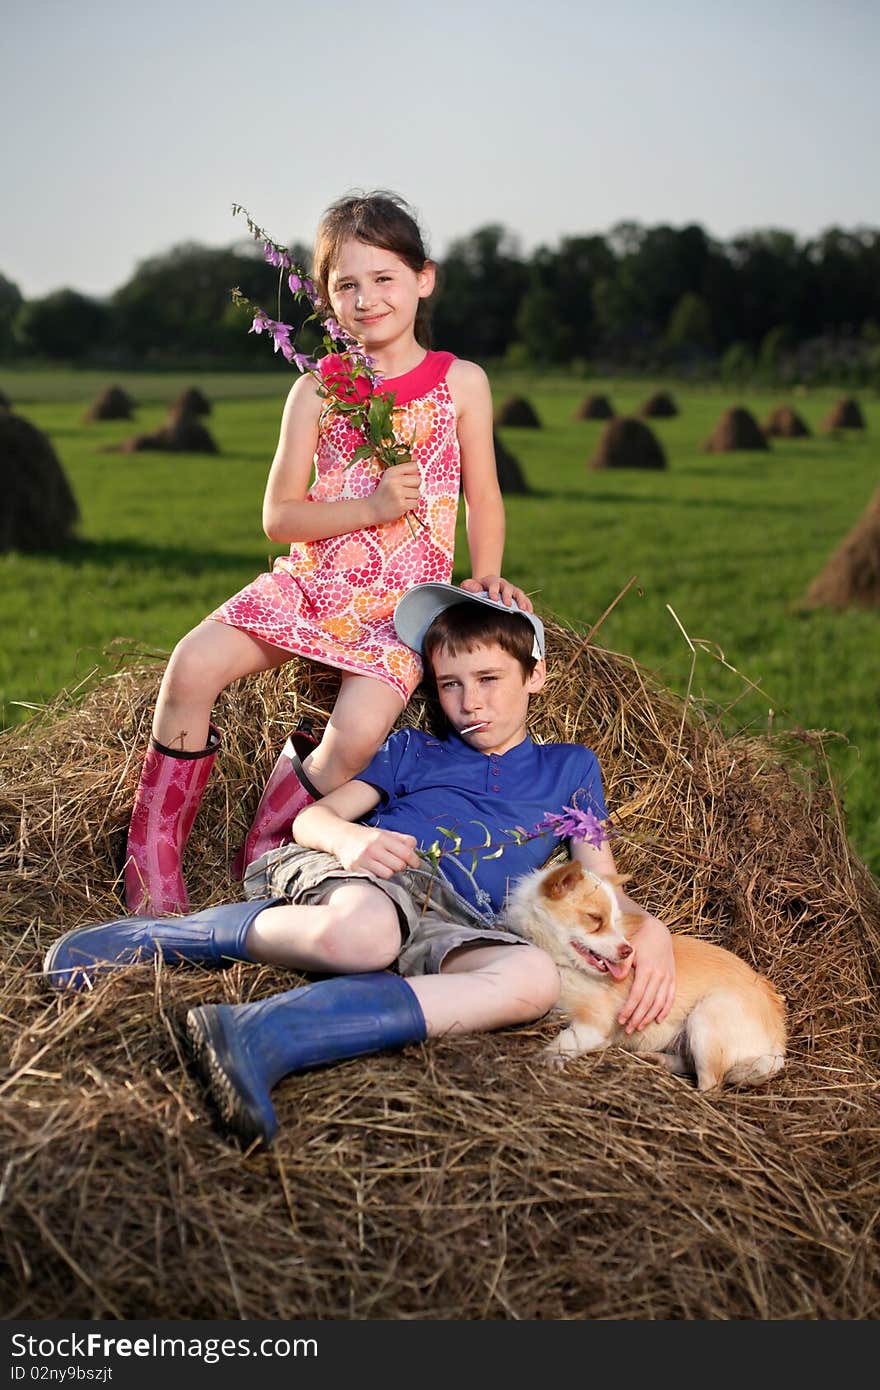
[245, 845, 525, 974]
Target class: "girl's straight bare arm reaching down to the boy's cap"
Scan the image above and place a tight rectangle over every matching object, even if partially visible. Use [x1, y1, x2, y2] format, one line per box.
[446, 359, 532, 613]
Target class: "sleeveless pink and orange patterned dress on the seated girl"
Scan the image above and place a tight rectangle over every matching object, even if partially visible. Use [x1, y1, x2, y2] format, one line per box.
[209, 352, 460, 703]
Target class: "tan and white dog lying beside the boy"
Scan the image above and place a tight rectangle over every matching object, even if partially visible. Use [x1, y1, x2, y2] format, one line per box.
[506, 859, 785, 1091]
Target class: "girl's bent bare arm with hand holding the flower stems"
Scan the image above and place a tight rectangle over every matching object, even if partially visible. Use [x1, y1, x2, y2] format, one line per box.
[263, 374, 420, 545]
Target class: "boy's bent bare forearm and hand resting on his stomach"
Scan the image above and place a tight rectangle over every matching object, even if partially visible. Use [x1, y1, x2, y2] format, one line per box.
[293, 783, 420, 878]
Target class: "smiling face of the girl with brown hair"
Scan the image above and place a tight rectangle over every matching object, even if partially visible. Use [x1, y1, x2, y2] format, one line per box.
[329, 238, 434, 352]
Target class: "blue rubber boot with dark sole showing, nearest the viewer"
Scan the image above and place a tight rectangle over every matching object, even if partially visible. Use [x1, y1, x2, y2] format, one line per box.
[186, 970, 427, 1147]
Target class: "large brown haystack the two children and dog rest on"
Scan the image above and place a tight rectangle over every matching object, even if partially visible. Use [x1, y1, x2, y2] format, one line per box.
[0, 621, 880, 1319]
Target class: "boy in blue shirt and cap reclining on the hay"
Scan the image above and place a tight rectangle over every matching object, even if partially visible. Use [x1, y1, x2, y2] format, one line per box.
[44, 584, 674, 1144]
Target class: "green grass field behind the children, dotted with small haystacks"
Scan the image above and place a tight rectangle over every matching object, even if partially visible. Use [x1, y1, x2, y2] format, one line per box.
[0, 371, 880, 873]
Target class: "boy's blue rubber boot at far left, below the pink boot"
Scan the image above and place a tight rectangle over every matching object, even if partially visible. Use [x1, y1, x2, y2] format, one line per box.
[43, 898, 285, 990]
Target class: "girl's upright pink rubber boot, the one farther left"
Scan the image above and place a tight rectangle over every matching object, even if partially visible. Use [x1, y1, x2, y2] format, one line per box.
[125, 724, 220, 917]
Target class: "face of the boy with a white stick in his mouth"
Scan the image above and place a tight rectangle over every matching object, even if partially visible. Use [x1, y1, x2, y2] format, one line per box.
[432, 644, 546, 753]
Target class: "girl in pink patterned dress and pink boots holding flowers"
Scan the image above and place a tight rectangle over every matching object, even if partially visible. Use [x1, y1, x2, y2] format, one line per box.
[125, 193, 531, 915]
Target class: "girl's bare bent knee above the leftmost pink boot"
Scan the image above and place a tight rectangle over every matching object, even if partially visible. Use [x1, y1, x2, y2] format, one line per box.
[153, 619, 291, 752]
